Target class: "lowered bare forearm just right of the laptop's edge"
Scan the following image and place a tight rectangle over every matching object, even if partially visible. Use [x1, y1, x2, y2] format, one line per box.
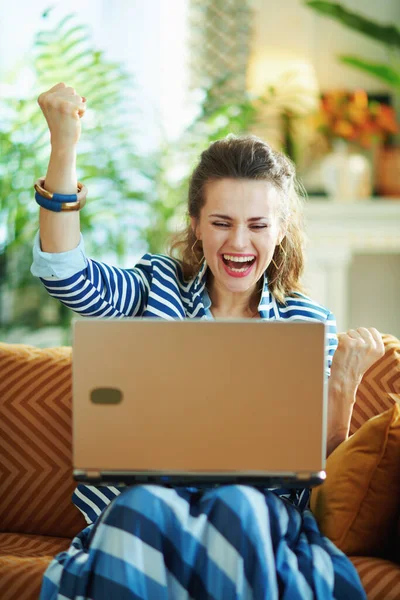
[326, 371, 359, 456]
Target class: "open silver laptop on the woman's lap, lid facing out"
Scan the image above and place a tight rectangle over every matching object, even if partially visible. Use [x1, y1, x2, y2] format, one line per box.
[73, 318, 327, 487]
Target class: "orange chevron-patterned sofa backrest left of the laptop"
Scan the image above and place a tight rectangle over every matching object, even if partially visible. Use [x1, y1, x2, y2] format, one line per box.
[0, 343, 86, 538]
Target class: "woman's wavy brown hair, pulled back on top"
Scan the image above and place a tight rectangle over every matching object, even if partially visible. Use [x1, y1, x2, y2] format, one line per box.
[169, 134, 304, 303]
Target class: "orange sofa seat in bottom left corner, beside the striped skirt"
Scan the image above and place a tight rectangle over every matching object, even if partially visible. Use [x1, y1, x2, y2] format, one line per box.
[0, 533, 71, 600]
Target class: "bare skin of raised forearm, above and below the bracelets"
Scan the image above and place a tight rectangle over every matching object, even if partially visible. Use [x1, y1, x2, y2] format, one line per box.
[39, 146, 80, 253]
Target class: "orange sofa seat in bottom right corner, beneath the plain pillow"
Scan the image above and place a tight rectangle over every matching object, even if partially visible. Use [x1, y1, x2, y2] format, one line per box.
[350, 556, 400, 600]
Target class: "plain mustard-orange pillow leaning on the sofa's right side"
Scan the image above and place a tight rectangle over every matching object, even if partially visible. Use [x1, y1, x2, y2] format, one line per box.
[311, 394, 400, 558]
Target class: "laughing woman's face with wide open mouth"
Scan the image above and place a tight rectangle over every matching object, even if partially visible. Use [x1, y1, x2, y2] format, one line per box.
[192, 179, 284, 292]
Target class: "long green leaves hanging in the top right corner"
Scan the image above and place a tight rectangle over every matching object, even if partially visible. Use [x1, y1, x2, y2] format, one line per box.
[305, 0, 400, 94]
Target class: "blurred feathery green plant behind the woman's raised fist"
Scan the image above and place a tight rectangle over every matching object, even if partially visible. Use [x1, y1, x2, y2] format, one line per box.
[0, 11, 151, 328]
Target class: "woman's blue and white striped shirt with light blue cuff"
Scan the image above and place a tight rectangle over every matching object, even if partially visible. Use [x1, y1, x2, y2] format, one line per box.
[31, 232, 337, 523]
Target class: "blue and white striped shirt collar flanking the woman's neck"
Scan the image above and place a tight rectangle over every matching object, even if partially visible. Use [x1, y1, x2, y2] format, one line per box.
[186, 259, 279, 319]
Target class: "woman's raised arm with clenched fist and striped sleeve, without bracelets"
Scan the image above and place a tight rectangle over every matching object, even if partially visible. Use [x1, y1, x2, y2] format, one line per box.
[31, 83, 152, 317]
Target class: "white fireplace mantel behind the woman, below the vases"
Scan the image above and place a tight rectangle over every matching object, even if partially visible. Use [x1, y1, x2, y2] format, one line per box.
[303, 198, 400, 335]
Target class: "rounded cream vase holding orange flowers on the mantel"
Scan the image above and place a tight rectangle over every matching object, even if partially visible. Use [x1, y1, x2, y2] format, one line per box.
[321, 140, 372, 202]
